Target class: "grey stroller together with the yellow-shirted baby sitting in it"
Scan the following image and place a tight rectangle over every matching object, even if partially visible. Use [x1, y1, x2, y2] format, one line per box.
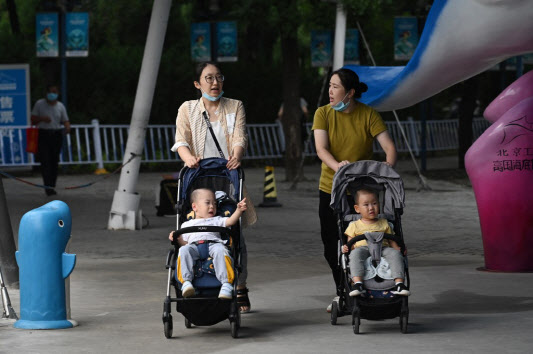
[330, 161, 411, 334]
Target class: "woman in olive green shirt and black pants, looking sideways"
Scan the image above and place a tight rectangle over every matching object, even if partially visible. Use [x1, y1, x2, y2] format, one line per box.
[313, 69, 397, 311]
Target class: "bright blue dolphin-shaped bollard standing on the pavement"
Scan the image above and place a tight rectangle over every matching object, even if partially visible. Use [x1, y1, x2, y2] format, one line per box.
[13, 200, 76, 329]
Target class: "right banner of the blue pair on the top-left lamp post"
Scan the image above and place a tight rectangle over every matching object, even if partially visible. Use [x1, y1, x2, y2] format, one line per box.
[65, 12, 89, 57]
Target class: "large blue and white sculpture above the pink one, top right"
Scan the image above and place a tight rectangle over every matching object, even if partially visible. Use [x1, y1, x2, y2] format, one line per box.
[345, 0, 533, 111]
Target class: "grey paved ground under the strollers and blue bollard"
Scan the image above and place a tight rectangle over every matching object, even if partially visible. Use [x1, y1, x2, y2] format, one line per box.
[0, 158, 533, 353]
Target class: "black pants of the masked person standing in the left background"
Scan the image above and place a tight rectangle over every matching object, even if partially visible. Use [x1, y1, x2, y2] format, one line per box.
[38, 129, 63, 187]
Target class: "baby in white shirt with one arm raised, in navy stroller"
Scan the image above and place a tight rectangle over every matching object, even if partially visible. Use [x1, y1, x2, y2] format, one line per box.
[168, 188, 246, 299]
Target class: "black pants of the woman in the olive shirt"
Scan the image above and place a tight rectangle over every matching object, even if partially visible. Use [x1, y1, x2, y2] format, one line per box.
[318, 191, 354, 295]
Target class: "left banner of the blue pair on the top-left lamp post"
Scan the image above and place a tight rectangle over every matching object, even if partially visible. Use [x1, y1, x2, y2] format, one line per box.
[35, 13, 59, 57]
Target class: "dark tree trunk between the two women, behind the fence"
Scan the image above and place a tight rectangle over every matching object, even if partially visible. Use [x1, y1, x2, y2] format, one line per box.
[281, 32, 302, 181]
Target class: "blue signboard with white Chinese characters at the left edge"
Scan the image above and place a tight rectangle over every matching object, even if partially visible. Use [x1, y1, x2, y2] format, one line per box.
[0, 64, 30, 164]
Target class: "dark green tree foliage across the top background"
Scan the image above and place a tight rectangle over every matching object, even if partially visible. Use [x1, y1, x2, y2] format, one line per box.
[0, 0, 494, 128]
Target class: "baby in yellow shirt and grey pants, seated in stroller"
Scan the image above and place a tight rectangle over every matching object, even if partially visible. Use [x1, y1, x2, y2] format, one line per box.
[342, 189, 411, 296]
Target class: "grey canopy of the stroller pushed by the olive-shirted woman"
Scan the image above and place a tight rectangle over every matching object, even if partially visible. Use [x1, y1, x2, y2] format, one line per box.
[330, 160, 405, 217]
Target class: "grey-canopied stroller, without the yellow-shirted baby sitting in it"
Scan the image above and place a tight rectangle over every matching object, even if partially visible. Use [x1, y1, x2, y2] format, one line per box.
[330, 161, 409, 334]
